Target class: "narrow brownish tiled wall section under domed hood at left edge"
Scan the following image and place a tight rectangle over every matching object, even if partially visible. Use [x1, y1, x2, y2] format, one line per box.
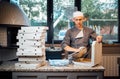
[0, 27, 7, 46]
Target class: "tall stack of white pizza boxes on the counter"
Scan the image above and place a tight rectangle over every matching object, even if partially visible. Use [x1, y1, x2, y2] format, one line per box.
[15, 26, 48, 68]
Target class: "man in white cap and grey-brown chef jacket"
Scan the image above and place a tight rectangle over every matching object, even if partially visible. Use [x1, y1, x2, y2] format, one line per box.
[61, 11, 102, 58]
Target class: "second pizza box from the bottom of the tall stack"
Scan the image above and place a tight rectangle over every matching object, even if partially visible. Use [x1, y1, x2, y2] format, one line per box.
[18, 55, 46, 61]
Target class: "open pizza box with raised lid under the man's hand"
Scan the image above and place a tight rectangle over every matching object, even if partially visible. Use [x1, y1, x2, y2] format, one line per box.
[73, 41, 102, 67]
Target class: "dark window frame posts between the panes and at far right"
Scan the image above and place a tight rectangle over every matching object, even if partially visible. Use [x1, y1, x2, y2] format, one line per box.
[46, 0, 120, 44]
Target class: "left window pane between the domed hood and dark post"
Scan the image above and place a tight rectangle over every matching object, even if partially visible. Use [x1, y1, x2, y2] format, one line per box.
[19, 0, 47, 26]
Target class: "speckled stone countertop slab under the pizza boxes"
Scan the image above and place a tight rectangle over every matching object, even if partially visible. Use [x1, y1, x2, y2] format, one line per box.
[0, 61, 105, 72]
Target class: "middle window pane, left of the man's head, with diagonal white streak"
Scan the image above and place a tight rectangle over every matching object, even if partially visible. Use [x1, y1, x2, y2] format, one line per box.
[53, 0, 77, 40]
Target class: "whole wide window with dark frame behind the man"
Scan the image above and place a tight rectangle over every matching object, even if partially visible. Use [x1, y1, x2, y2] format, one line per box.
[19, 0, 120, 43]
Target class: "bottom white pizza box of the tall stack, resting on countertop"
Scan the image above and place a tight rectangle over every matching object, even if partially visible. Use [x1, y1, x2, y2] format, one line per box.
[15, 61, 46, 69]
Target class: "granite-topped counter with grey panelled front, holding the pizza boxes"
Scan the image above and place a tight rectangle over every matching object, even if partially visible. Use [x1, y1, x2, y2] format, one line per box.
[0, 61, 104, 79]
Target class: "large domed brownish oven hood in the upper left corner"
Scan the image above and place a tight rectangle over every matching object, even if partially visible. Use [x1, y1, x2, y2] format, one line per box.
[0, 1, 29, 26]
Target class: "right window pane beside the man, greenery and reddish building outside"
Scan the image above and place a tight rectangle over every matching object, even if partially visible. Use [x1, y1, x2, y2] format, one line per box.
[81, 0, 118, 43]
